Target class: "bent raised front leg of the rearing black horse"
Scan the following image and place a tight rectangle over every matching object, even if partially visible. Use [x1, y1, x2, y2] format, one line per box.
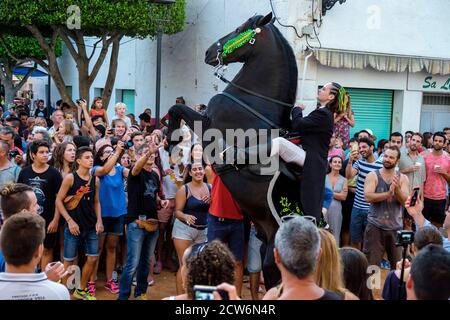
[167, 104, 208, 145]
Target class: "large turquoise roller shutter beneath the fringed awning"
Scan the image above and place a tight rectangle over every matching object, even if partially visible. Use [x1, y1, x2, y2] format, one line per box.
[347, 88, 394, 141]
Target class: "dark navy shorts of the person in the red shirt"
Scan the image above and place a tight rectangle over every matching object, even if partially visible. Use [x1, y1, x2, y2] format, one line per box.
[207, 213, 244, 262]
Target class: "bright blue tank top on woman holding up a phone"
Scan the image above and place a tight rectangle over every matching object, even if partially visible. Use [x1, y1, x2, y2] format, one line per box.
[93, 165, 127, 218]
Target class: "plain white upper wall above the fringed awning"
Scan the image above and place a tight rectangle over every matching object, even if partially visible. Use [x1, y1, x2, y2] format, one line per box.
[319, 0, 450, 59]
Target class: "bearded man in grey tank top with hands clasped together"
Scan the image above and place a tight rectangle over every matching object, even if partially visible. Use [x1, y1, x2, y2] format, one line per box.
[363, 146, 409, 269]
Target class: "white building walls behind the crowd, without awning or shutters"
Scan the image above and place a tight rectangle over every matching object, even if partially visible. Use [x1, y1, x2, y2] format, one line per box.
[34, 0, 450, 127]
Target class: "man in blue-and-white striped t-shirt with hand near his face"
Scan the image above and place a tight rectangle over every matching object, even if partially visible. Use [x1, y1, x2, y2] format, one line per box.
[345, 138, 383, 250]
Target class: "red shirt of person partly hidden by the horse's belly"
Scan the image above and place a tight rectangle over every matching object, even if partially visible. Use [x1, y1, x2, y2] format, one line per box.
[209, 171, 244, 220]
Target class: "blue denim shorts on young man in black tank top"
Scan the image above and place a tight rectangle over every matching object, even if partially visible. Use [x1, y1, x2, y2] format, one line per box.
[64, 227, 98, 261]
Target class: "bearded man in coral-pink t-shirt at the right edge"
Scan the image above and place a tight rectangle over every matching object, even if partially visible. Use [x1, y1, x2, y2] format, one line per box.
[423, 132, 450, 227]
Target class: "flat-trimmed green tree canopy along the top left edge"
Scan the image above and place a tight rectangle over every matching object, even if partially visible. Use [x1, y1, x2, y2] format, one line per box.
[0, 0, 185, 38]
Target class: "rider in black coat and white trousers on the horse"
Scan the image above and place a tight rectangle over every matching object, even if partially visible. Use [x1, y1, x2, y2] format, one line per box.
[271, 82, 346, 221]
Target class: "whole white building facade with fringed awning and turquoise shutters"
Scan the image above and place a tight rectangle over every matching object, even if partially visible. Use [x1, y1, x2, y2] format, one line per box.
[33, 0, 450, 139]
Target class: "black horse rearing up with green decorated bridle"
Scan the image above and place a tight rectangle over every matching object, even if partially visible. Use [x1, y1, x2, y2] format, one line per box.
[165, 13, 300, 288]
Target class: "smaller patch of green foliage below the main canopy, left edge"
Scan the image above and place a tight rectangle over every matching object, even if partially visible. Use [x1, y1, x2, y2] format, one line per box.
[0, 36, 62, 61]
